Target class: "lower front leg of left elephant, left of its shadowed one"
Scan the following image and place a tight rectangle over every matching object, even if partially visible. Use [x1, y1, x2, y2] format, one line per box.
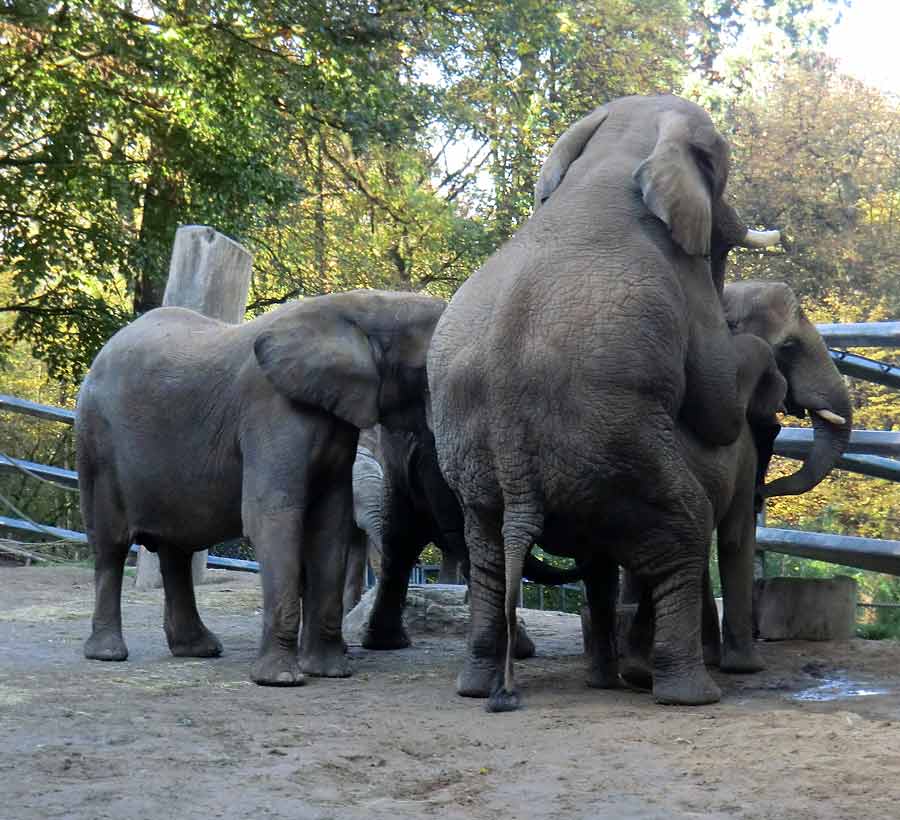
[244, 509, 305, 686]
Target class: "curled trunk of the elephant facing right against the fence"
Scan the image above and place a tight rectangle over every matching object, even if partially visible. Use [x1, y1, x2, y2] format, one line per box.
[763, 360, 853, 497]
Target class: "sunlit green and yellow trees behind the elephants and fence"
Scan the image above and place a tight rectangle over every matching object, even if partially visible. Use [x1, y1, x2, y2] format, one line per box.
[0, 0, 900, 597]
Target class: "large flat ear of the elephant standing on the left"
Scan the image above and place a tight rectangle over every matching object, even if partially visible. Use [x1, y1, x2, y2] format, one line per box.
[253, 303, 381, 428]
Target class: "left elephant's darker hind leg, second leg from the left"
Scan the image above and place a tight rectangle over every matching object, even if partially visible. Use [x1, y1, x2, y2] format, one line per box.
[158, 545, 222, 658]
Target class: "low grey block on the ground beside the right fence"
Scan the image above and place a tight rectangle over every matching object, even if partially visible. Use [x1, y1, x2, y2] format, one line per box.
[754, 575, 856, 641]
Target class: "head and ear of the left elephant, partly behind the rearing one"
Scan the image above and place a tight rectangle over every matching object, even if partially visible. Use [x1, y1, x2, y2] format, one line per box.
[253, 290, 446, 429]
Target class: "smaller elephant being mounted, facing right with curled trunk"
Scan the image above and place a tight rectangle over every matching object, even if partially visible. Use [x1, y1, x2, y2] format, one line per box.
[620, 282, 852, 686]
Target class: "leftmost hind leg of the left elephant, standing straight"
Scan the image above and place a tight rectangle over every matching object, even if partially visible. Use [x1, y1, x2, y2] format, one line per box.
[81, 470, 130, 661]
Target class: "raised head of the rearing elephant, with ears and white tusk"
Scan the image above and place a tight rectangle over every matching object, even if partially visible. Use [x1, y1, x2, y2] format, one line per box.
[534, 96, 781, 293]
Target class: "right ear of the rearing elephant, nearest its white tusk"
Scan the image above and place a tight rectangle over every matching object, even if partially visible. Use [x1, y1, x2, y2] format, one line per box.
[634, 111, 727, 256]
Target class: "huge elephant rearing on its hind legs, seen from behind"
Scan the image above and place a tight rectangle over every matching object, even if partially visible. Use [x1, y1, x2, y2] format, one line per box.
[428, 96, 778, 710]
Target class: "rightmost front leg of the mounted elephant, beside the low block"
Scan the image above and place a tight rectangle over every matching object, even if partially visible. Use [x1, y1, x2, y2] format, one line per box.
[718, 506, 766, 673]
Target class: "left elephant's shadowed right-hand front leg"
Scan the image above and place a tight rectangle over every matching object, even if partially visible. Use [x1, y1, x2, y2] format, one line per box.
[300, 481, 356, 678]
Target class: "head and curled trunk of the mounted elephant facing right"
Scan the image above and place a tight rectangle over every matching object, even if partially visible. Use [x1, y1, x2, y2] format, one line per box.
[723, 282, 852, 496]
